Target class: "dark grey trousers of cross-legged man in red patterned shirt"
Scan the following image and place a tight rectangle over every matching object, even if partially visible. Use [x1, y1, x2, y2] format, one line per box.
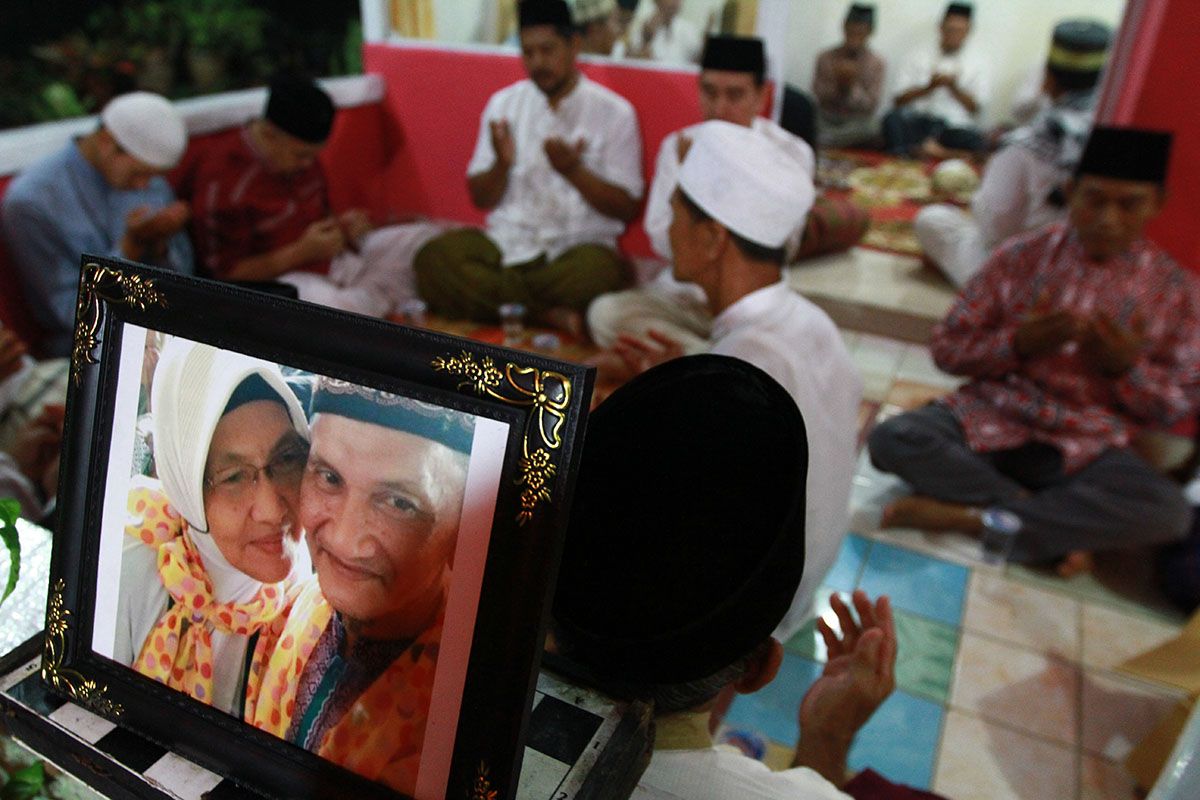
[868, 403, 1192, 563]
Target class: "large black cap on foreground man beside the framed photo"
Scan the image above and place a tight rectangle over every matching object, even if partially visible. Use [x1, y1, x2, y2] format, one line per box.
[554, 355, 808, 686]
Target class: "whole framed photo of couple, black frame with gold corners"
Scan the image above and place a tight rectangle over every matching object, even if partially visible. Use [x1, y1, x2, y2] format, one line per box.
[42, 257, 593, 799]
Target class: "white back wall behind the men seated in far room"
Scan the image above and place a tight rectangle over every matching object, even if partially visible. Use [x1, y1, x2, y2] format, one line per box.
[785, 0, 1126, 125]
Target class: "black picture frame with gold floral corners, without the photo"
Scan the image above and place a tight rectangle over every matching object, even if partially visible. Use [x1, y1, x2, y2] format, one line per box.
[42, 255, 594, 798]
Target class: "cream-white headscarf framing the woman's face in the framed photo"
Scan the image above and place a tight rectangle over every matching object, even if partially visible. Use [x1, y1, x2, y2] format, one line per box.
[150, 337, 308, 531]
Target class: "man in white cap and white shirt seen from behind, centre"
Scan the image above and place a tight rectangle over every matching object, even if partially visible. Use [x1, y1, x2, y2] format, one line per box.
[600, 120, 862, 639]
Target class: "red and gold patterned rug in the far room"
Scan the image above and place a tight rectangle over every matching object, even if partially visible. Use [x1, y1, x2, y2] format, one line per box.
[816, 150, 970, 257]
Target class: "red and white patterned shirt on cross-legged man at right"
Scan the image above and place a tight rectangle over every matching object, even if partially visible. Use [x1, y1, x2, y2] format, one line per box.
[930, 224, 1200, 473]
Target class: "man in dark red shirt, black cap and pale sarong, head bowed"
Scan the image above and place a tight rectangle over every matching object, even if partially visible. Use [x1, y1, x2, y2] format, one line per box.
[173, 77, 438, 317]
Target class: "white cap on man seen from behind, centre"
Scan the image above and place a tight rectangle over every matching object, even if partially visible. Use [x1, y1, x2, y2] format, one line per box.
[679, 120, 815, 248]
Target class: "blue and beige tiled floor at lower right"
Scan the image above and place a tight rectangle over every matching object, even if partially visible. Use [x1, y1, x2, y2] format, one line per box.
[725, 289, 1182, 800]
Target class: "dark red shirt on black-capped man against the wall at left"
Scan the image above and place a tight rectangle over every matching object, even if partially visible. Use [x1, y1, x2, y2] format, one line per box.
[173, 128, 330, 278]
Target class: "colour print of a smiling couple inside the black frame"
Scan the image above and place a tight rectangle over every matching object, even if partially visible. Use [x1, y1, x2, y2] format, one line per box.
[97, 331, 498, 795]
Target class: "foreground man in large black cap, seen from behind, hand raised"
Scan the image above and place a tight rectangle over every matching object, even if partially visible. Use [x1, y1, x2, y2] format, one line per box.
[546, 355, 896, 800]
